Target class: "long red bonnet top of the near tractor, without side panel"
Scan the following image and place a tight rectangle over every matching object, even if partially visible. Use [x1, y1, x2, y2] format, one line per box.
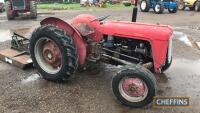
[101, 21, 173, 41]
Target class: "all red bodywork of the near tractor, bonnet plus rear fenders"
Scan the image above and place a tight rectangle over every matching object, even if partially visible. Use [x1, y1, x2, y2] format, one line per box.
[41, 14, 173, 72]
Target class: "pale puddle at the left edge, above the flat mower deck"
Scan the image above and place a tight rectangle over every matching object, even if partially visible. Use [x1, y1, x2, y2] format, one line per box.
[0, 30, 12, 42]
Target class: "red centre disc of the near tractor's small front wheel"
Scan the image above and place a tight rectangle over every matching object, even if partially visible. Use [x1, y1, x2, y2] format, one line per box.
[122, 78, 145, 97]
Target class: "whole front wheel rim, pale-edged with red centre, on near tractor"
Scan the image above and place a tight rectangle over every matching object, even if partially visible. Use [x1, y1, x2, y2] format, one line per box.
[119, 77, 148, 102]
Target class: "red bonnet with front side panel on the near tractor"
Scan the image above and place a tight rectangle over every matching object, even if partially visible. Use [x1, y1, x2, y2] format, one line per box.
[101, 21, 172, 72]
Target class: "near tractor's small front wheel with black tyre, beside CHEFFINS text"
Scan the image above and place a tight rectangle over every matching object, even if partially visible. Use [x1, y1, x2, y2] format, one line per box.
[112, 66, 157, 108]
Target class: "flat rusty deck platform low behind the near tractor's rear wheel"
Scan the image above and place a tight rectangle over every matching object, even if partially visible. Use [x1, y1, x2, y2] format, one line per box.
[0, 48, 32, 69]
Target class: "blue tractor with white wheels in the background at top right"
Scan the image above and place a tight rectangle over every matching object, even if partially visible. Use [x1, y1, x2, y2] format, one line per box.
[140, 0, 178, 14]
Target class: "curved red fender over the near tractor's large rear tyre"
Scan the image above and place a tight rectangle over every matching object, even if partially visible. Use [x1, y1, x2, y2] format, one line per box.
[40, 17, 86, 65]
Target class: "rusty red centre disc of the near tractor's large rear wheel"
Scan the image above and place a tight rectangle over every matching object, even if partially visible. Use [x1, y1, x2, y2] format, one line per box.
[42, 40, 61, 68]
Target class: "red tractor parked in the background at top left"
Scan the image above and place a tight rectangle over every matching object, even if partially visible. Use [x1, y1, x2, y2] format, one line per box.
[6, 0, 37, 20]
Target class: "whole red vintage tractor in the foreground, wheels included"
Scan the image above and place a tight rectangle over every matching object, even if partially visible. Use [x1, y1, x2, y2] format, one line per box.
[30, 14, 173, 107]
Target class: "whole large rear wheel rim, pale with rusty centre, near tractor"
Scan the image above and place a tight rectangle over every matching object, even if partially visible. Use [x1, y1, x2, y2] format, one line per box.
[34, 37, 62, 74]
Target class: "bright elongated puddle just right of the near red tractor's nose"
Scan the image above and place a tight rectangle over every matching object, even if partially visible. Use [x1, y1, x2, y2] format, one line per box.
[174, 31, 192, 47]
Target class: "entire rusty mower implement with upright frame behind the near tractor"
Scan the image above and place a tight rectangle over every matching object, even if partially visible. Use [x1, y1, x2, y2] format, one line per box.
[0, 28, 32, 69]
